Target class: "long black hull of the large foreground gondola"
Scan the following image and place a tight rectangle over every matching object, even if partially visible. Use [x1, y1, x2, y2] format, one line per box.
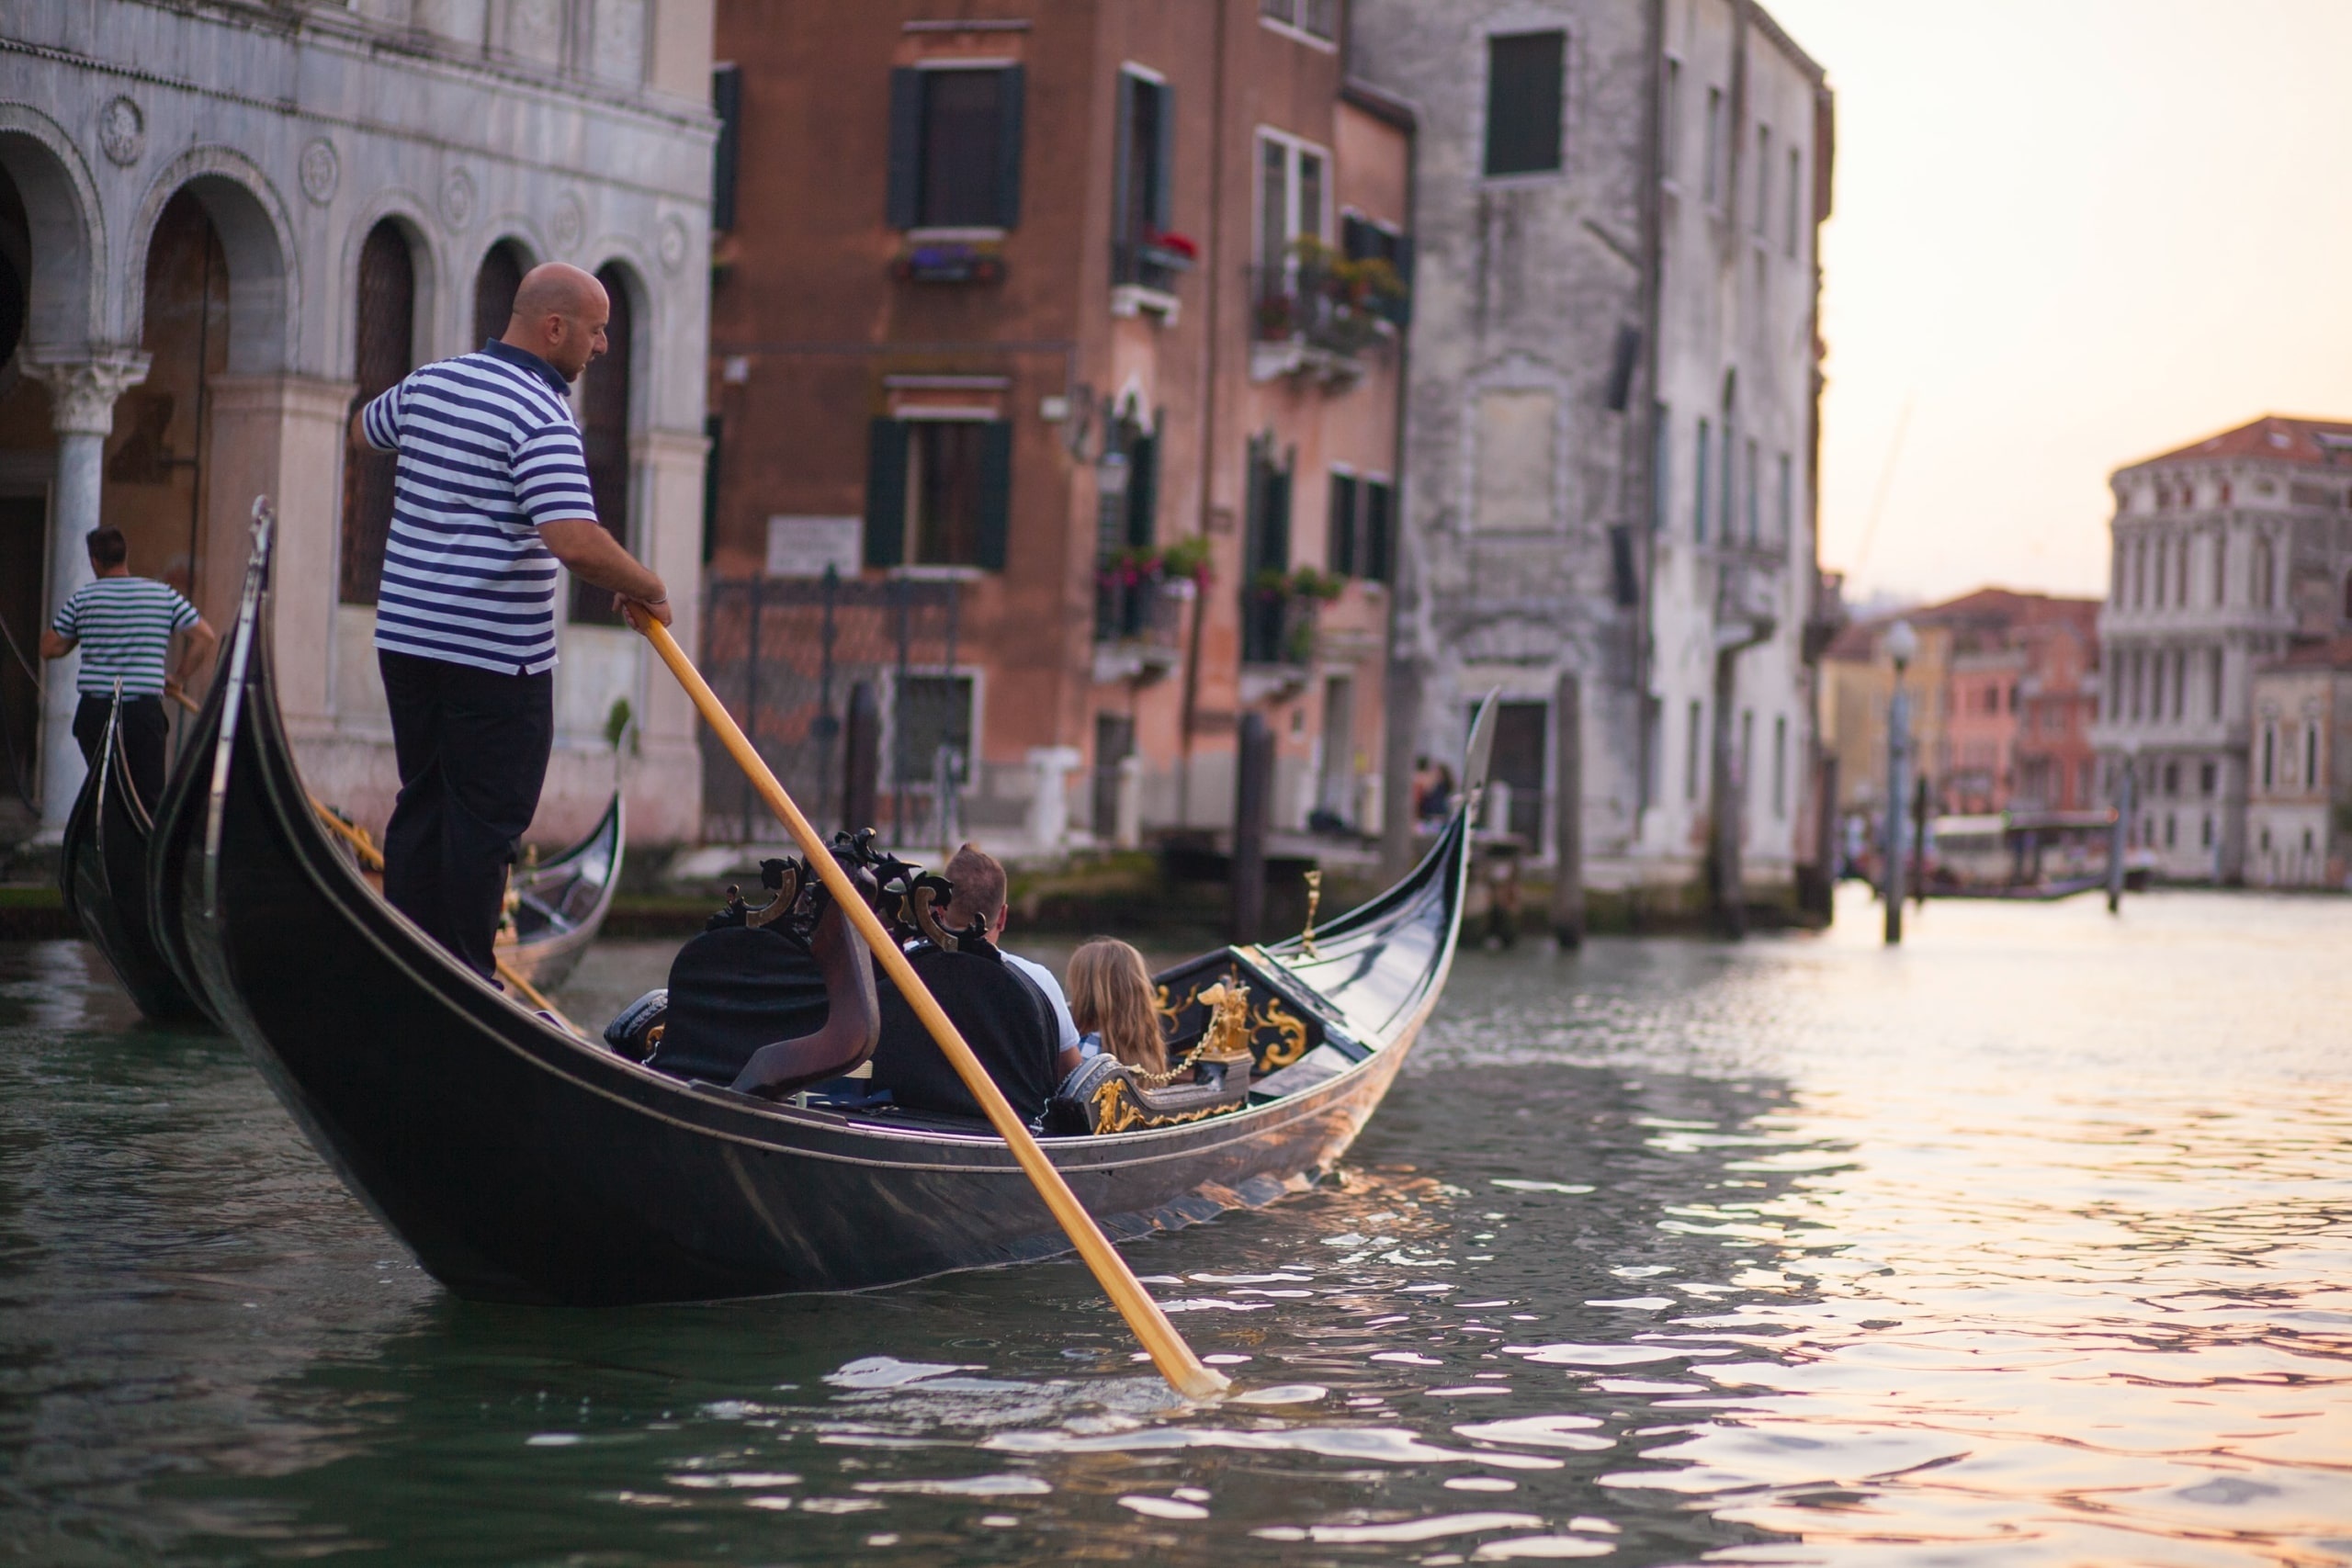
[155, 529, 1484, 1304]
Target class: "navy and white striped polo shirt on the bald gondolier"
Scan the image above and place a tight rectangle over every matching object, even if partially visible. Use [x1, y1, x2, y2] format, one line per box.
[360, 341, 595, 674]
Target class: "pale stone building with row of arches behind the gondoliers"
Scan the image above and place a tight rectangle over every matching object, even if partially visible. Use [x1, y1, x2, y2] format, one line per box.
[0, 0, 715, 841]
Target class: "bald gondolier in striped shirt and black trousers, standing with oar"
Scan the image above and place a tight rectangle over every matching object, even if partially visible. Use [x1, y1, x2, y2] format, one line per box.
[353, 261, 671, 978]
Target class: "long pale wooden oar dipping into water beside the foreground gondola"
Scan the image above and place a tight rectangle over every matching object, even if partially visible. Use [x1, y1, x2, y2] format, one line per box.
[628, 609, 1226, 1399]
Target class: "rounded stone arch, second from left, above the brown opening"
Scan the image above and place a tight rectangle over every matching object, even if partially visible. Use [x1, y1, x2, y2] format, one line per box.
[122, 146, 301, 376]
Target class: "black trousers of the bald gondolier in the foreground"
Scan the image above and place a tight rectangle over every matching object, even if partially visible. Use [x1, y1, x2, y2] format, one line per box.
[377, 649, 555, 978]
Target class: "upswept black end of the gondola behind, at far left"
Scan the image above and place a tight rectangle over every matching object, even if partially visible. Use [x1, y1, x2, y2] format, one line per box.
[56, 701, 205, 1022]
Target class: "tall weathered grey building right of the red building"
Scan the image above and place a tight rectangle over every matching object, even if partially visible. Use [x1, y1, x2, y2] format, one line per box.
[1350, 0, 1832, 896]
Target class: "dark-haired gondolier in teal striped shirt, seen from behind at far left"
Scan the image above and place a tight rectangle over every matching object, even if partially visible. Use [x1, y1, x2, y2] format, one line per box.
[40, 526, 219, 811]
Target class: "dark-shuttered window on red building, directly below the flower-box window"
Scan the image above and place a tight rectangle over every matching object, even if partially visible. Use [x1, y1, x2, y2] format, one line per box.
[865, 419, 1013, 571]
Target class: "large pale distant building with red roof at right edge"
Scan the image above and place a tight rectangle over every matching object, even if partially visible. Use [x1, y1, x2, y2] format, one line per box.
[2093, 413, 2352, 882]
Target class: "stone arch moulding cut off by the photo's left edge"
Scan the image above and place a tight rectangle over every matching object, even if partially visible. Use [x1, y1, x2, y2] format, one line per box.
[0, 104, 108, 355]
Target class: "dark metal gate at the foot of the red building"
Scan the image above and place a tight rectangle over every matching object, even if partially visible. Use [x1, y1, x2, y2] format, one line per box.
[703, 571, 971, 844]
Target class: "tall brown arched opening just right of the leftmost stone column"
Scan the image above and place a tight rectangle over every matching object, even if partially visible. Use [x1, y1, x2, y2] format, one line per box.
[104, 188, 231, 597]
